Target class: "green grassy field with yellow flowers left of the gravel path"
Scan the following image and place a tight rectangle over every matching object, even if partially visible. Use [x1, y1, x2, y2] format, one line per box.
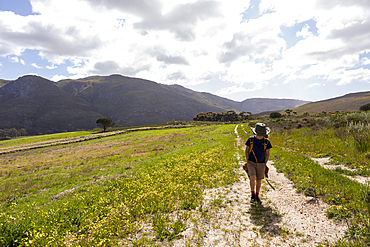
[0, 125, 238, 246]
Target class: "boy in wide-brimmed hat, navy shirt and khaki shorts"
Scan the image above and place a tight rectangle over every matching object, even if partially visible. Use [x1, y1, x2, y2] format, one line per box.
[245, 123, 272, 203]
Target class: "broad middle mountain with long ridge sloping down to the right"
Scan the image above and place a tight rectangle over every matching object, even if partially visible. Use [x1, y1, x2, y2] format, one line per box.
[58, 75, 226, 126]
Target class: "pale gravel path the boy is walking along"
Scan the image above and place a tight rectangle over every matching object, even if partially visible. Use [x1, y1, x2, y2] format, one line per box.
[174, 126, 346, 246]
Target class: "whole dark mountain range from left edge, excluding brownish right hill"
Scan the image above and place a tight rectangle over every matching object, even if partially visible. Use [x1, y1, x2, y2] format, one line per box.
[0, 75, 308, 134]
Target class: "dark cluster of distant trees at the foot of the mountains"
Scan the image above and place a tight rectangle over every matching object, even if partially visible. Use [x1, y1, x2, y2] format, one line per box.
[193, 110, 252, 122]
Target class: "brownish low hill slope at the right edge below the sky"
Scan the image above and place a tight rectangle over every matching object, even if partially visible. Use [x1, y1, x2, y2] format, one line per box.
[294, 92, 370, 114]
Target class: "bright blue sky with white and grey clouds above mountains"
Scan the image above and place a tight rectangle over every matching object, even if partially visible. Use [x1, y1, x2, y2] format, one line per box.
[0, 0, 370, 101]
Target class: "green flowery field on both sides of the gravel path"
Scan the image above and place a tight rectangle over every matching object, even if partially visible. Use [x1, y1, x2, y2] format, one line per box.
[0, 116, 370, 246]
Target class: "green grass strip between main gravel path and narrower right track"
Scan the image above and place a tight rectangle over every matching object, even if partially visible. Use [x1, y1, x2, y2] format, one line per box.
[272, 148, 370, 246]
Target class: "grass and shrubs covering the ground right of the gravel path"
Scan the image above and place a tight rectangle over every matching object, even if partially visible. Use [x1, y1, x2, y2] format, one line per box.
[260, 112, 370, 246]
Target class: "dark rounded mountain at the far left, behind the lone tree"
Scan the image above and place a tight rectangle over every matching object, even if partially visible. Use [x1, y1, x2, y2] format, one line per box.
[0, 76, 100, 133]
